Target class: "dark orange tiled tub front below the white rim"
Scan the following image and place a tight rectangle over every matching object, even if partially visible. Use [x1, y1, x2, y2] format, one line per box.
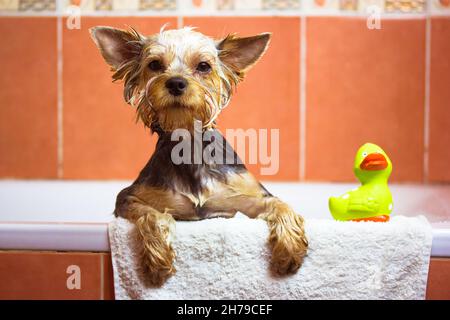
[0, 251, 450, 300]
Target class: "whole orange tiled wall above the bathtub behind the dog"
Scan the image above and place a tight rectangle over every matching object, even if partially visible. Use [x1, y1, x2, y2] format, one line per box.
[0, 17, 450, 183]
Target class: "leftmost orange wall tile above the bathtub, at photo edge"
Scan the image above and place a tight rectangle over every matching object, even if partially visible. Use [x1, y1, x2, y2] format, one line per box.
[0, 18, 58, 178]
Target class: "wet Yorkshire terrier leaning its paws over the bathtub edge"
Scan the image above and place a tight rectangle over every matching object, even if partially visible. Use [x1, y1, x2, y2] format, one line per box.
[90, 27, 308, 286]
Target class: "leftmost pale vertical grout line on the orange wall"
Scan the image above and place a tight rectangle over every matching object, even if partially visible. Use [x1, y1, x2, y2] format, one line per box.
[56, 17, 64, 179]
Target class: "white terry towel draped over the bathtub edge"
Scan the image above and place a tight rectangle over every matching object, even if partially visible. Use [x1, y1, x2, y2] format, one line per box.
[109, 216, 432, 299]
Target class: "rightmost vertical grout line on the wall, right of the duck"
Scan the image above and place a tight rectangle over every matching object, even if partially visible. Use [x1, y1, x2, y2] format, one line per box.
[423, 17, 431, 183]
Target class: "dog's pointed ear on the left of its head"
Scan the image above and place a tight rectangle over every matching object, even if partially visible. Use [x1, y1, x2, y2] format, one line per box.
[89, 27, 145, 70]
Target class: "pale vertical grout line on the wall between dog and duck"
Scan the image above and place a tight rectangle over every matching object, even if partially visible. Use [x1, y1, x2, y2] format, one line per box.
[299, 17, 307, 181]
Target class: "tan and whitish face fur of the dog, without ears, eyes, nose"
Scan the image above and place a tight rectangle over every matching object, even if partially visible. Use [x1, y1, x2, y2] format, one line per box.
[134, 28, 236, 131]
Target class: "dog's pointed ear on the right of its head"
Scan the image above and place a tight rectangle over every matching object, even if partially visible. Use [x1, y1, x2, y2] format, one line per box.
[217, 33, 272, 75]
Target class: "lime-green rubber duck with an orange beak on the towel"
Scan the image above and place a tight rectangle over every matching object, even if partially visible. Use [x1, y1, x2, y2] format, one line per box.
[328, 143, 393, 222]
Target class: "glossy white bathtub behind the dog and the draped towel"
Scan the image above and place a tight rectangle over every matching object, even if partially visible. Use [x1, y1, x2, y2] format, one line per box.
[0, 180, 450, 257]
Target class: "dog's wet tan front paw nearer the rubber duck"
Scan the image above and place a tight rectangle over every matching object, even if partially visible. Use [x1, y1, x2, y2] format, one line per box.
[268, 211, 308, 275]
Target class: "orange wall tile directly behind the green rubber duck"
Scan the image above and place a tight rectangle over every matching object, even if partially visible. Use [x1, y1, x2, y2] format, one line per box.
[306, 18, 425, 182]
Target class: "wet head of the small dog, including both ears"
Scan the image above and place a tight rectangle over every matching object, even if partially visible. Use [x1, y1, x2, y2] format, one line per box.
[90, 27, 271, 131]
